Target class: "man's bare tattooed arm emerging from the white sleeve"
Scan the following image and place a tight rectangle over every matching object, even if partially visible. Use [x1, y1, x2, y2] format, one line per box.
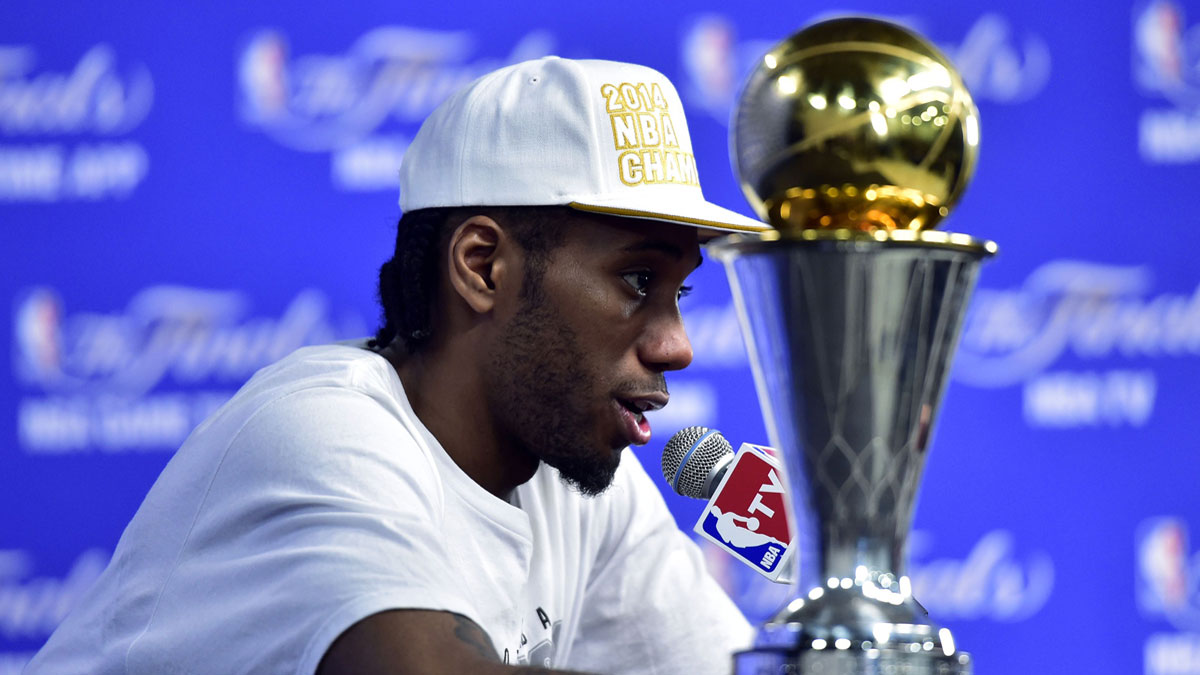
[317, 609, 595, 675]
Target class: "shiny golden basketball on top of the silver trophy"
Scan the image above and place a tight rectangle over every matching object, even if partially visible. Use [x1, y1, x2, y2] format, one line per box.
[733, 19, 979, 231]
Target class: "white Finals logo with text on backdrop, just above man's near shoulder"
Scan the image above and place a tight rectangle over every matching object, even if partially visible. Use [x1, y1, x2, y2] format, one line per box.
[13, 286, 365, 455]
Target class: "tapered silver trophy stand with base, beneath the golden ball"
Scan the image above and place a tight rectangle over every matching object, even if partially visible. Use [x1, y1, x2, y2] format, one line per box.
[709, 233, 994, 675]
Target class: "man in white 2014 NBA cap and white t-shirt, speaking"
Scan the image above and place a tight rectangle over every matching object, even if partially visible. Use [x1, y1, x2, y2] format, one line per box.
[29, 58, 777, 674]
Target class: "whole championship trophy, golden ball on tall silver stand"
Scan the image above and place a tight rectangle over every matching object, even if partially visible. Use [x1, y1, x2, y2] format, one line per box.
[709, 18, 996, 675]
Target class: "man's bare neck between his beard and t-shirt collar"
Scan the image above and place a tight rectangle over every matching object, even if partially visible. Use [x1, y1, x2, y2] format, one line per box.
[379, 344, 539, 501]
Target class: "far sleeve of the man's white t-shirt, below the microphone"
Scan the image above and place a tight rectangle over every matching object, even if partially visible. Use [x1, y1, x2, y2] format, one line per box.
[569, 452, 754, 675]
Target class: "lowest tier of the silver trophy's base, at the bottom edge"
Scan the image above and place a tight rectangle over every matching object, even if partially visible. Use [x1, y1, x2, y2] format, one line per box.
[733, 643, 972, 675]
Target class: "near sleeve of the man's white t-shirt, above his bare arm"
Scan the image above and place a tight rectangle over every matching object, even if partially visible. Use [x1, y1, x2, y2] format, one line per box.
[123, 388, 472, 674]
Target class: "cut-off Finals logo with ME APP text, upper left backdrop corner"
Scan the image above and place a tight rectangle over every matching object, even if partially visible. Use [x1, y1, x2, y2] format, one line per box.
[0, 44, 154, 203]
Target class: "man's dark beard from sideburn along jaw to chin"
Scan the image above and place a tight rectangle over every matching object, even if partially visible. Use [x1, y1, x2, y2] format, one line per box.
[486, 280, 620, 496]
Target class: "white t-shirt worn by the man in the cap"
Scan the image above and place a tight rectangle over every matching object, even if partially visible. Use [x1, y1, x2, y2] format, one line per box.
[26, 345, 751, 675]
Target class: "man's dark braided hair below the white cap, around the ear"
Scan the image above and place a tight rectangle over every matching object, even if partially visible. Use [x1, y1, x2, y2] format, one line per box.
[367, 207, 570, 354]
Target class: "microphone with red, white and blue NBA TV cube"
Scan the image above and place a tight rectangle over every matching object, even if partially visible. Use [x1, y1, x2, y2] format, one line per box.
[662, 426, 797, 584]
